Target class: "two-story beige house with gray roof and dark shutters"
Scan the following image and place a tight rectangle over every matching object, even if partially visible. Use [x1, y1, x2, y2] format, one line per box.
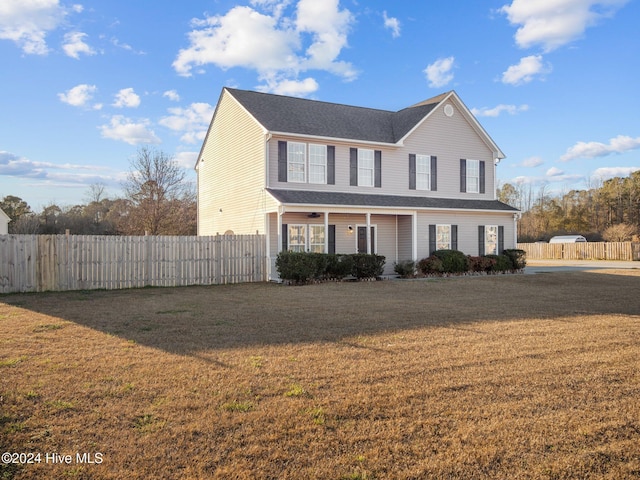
[196, 88, 518, 278]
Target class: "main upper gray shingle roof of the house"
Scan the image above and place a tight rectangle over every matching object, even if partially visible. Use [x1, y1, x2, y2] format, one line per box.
[226, 88, 439, 143]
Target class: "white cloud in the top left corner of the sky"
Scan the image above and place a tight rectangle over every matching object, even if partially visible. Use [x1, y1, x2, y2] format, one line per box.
[0, 0, 66, 55]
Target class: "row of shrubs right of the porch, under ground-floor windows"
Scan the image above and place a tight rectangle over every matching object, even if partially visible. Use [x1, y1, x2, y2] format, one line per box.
[394, 249, 527, 278]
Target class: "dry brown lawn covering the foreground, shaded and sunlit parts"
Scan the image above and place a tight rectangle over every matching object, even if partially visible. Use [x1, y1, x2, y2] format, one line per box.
[0, 270, 640, 479]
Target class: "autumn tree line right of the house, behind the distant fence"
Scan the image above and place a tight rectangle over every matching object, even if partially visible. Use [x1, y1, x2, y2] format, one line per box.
[497, 171, 640, 243]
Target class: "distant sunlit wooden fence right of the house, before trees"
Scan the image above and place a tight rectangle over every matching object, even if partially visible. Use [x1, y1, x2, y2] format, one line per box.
[518, 242, 640, 260]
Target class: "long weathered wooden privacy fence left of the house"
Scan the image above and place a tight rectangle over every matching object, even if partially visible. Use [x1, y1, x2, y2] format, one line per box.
[0, 235, 267, 293]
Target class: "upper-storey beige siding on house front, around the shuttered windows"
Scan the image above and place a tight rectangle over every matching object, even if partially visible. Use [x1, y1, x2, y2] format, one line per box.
[269, 102, 496, 200]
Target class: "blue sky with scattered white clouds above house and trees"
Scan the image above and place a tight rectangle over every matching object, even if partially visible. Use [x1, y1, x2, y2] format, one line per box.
[0, 0, 640, 210]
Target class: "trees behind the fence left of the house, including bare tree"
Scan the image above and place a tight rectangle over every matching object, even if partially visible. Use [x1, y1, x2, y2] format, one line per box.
[0, 147, 197, 235]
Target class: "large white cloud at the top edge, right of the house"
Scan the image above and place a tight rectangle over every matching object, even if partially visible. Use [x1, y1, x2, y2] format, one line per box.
[499, 0, 629, 52]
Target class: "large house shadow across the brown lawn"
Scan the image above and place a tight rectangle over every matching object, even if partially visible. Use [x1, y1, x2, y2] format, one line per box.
[0, 272, 640, 356]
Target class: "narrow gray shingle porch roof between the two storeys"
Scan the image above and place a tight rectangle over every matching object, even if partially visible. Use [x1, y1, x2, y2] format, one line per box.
[267, 188, 518, 213]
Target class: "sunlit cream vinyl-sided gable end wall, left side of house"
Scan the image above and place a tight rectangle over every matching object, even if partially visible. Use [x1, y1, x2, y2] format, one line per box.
[198, 90, 274, 235]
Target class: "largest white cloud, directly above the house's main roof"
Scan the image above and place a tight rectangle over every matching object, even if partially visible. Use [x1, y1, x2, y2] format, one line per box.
[173, 0, 357, 95]
